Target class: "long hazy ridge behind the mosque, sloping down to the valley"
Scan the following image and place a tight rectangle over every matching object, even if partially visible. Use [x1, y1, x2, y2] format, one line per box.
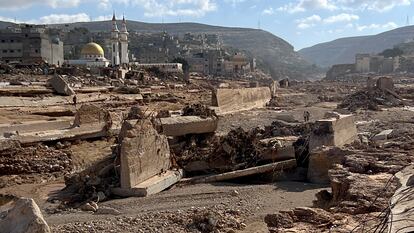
[0, 21, 319, 79]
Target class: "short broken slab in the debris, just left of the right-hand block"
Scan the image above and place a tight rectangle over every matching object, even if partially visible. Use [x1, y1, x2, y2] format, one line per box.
[259, 136, 298, 161]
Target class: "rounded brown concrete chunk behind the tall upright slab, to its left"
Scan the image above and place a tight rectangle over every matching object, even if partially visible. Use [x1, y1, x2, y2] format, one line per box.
[73, 104, 112, 129]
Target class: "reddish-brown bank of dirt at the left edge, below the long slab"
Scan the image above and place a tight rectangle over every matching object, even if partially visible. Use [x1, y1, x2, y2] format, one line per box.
[0, 144, 72, 187]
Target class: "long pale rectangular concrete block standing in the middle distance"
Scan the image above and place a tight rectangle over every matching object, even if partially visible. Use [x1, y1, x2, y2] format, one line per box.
[212, 87, 272, 114]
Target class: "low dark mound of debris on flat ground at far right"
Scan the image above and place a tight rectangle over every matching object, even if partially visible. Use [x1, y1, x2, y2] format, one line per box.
[338, 89, 404, 111]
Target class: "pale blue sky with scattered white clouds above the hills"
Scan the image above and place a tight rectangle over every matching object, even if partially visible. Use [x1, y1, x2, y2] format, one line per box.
[0, 0, 414, 50]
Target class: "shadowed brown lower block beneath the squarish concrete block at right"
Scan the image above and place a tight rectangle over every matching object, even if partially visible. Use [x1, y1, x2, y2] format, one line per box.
[307, 147, 348, 184]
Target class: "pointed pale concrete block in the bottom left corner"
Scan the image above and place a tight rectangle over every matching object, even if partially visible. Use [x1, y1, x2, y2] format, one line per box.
[0, 198, 50, 233]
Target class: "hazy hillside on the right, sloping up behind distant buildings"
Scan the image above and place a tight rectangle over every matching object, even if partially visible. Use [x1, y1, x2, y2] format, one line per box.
[299, 26, 414, 67]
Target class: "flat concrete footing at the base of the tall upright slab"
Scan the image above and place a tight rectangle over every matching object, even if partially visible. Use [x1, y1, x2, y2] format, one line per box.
[112, 170, 183, 197]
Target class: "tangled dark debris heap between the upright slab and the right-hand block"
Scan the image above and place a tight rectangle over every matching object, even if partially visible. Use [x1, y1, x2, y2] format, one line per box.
[172, 118, 310, 172]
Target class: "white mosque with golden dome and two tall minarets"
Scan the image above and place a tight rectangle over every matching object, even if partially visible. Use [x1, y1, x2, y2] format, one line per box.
[66, 14, 129, 67]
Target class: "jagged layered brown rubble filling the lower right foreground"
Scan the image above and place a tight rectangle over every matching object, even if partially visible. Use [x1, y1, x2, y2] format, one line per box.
[265, 113, 412, 232]
